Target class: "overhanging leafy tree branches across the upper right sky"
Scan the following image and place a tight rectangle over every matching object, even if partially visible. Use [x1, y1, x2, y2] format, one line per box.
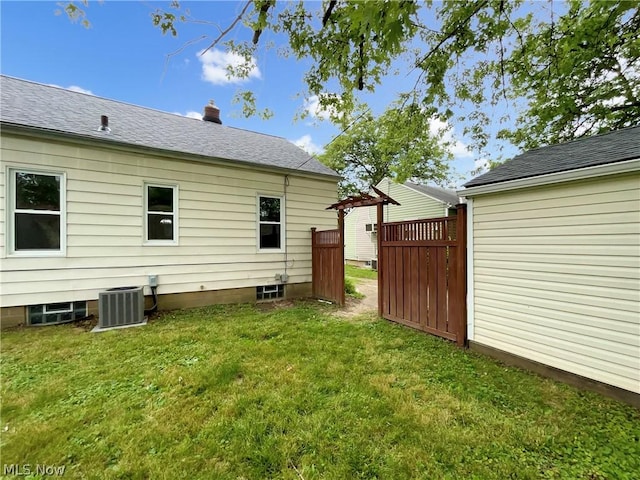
[61, 0, 640, 163]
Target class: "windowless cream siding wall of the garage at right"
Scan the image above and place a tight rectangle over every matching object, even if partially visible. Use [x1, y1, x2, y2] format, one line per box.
[473, 173, 640, 393]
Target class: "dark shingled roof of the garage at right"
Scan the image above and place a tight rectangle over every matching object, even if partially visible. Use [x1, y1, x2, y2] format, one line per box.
[464, 126, 640, 188]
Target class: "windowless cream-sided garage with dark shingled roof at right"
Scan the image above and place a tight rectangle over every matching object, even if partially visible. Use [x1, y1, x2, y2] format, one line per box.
[459, 127, 640, 403]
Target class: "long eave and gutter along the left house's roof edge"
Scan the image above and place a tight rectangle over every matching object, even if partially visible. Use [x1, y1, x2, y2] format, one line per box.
[0, 121, 342, 181]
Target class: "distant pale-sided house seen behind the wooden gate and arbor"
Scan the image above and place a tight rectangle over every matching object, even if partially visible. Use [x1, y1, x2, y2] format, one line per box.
[344, 178, 460, 267]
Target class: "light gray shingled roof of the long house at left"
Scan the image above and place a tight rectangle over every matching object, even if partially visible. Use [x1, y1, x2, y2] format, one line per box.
[0, 75, 338, 176]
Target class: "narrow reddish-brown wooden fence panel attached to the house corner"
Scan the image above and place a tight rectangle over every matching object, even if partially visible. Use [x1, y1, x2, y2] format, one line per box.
[311, 228, 344, 305]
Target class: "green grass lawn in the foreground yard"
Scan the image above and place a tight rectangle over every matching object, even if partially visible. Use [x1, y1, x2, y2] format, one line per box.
[0, 302, 640, 480]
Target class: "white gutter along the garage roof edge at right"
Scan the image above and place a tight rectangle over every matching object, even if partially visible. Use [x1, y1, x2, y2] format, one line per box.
[456, 158, 640, 198]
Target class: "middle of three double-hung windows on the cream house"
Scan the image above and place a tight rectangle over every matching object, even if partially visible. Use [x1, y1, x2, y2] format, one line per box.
[145, 184, 178, 243]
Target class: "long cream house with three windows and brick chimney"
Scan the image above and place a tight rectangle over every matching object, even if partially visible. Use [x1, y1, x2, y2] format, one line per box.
[0, 76, 339, 326]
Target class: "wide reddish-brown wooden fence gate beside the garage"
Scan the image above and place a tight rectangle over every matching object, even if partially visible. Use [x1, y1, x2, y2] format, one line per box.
[378, 205, 466, 345]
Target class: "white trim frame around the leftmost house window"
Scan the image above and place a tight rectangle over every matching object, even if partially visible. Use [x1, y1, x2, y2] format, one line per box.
[5, 166, 67, 257]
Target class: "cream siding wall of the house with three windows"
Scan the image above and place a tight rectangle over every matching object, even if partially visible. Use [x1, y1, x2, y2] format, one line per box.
[0, 136, 336, 307]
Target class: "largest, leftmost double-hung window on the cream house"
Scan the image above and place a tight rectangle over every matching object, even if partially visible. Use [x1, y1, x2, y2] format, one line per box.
[9, 170, 64, 253]
